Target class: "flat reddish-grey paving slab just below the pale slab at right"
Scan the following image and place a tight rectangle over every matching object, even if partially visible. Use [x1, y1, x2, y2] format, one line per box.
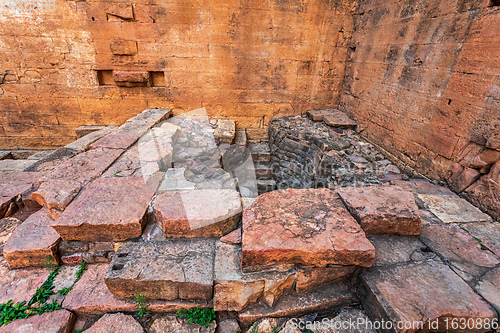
[420, 225, 500, 282]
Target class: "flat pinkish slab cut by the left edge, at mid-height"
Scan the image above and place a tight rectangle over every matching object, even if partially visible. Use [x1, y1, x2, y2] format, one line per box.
[0, 172, 42, 217]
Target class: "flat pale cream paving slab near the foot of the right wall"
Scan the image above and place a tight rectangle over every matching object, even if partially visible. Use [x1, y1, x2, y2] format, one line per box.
[418, 194, 491, 223]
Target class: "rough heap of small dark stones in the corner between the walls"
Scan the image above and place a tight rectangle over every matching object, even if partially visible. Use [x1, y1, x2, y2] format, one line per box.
[269, 116, 406, 189]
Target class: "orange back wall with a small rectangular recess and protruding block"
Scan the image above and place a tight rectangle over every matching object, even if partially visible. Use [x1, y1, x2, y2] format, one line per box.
[0, 0, 355, 149]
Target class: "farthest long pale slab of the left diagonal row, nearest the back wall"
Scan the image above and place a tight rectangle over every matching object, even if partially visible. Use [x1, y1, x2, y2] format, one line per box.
[91, 109, 172, 149]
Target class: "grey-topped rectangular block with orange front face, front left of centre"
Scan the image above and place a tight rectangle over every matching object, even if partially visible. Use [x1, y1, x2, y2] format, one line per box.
[105, 239, 215, 300]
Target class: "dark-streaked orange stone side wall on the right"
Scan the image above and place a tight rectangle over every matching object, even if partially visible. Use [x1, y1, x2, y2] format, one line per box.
[340, 0, 500, 216]
